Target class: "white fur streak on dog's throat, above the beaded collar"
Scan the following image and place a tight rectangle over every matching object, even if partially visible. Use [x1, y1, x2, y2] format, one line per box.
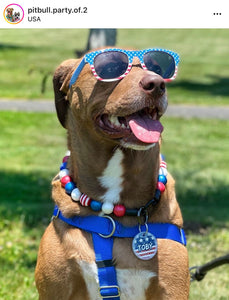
[99, 149, 124, 204]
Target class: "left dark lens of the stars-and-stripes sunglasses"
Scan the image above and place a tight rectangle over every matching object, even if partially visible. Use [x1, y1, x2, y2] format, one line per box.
[94, 51, 129, 79]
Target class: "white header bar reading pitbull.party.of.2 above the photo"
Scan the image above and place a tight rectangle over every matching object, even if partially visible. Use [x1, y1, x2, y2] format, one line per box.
[0, 0, 229, 28]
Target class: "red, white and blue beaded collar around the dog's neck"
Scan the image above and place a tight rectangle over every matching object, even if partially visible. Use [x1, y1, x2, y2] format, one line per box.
[59, 151, 168, 217]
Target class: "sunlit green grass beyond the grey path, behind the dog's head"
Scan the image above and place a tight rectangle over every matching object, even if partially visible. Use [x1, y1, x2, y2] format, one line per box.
[0, 29, 229, 105]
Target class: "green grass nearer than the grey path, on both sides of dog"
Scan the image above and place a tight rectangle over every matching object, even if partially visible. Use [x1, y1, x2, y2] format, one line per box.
[0, 112, 229, 300]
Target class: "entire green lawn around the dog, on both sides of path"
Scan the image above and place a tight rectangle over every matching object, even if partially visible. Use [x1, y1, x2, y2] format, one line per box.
[0, 29, 229, 300]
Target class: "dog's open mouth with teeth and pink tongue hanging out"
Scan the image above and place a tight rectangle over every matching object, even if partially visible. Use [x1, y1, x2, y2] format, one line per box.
[96, 107, 163, 144]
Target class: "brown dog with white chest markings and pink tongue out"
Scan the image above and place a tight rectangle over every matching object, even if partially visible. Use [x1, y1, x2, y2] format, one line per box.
[35, 48, 189, 300]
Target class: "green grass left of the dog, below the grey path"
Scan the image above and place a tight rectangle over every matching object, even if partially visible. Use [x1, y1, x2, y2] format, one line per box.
[0, 112, 66, 300]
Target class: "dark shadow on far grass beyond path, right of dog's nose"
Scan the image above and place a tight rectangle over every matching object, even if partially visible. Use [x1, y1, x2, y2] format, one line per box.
[170, 75, 229, 97]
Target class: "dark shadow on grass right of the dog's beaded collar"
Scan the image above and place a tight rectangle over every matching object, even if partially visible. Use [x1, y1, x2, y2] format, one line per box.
[176, 172, 229, 233]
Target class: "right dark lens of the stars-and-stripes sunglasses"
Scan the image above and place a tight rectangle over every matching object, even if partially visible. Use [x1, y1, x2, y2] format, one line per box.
[143, 51, 176, 79]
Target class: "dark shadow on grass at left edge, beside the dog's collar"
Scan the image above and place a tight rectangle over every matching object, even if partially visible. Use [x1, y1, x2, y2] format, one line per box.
[0, 172, 53, 228]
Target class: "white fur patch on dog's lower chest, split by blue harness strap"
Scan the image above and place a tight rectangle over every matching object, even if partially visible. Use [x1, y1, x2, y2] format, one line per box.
[79, 261, 156, 300]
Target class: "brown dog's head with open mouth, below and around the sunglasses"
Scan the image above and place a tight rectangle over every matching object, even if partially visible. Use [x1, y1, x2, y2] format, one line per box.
[54, 48, 178, 150]
